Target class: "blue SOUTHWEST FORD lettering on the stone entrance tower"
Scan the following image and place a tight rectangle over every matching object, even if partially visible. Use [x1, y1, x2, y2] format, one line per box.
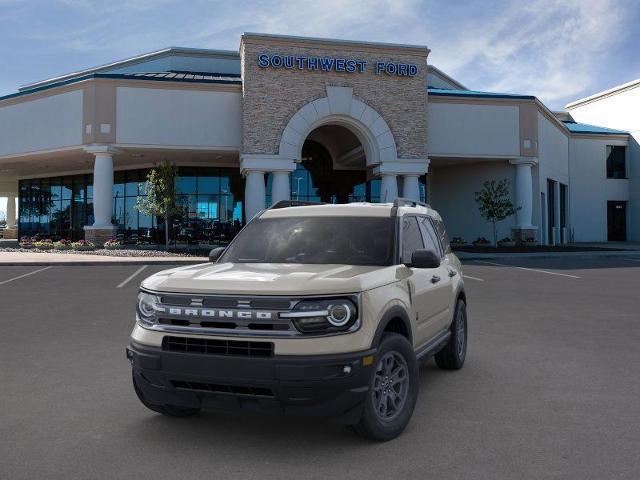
[258, 53, 418, 77]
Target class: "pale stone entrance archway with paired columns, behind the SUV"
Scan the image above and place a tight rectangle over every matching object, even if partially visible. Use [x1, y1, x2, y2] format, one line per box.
[240, 86, 428, 219]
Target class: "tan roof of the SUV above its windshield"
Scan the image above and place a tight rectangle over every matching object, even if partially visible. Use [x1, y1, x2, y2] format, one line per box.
[260, 202, 440, 219]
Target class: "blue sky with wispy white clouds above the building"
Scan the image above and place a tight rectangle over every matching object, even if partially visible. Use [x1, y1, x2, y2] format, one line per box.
[0, 0, 640, 215]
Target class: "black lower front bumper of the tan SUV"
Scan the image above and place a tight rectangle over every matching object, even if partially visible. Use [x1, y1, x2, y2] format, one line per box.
[127, 342, 375, 423]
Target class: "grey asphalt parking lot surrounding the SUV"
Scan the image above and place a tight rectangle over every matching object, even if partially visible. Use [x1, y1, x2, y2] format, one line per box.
[0, 257, 640, 480]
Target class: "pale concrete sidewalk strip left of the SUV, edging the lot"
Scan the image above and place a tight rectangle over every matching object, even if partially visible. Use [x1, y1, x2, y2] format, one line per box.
[0, 252, 209, 267]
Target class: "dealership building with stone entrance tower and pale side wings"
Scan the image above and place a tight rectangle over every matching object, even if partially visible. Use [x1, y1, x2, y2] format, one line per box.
[0, 33, 640, 244]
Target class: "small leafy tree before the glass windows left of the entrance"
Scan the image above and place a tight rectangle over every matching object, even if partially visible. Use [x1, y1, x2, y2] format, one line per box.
[136, 160, 182, 250]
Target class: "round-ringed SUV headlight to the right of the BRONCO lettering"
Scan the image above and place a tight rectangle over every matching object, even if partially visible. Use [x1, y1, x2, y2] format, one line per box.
[280, 298, 358, 333]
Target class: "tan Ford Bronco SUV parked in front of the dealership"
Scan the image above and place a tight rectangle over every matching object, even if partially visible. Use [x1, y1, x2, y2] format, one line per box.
[127, 199, 467, 440]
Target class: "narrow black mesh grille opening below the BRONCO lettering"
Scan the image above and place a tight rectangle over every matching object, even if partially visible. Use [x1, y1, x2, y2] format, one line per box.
[162, 337, 273, 357]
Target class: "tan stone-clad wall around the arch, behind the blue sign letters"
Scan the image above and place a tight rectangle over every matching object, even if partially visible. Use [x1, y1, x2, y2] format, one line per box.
[240, 35, 429, 159]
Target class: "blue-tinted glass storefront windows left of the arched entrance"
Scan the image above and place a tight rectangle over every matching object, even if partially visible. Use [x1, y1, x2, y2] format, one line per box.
[19, 168, 244, 244]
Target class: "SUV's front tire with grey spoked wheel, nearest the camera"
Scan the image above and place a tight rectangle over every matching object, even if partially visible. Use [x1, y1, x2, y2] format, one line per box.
[352, 333, 419, 441]
